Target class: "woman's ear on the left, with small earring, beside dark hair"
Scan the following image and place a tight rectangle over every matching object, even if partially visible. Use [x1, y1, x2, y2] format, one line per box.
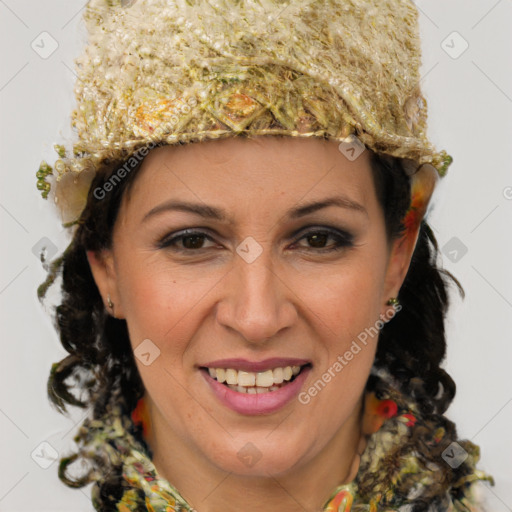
[86, 249, 124, 318]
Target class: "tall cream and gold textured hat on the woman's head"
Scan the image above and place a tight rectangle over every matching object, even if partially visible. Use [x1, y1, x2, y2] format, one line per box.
[37, 0, 452, 224]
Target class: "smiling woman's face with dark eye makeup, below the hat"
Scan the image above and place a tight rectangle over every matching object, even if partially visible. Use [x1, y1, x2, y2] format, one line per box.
[88, 137, 411, 475]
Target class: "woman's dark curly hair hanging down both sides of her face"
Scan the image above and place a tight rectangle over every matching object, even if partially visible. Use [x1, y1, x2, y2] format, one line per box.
[38, 139, 470, 511]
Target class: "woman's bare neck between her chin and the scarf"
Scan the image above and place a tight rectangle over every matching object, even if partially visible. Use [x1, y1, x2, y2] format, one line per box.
[147, 397, 366, 512]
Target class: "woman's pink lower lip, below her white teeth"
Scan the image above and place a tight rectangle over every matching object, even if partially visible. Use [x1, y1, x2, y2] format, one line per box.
[201, 366, 311, 415]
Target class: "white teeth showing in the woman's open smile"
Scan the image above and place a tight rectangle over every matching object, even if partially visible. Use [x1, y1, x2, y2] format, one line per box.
[208, 366, 301, 388]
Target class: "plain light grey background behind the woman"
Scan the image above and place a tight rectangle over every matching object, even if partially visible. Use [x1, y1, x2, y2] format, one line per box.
[0, 0, 512, 512]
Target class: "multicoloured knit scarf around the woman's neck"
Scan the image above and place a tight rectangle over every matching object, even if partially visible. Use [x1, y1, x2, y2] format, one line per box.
[68, 370, 494, 512]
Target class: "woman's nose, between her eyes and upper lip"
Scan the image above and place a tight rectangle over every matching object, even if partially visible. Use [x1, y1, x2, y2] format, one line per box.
[217, 248, 297, 344]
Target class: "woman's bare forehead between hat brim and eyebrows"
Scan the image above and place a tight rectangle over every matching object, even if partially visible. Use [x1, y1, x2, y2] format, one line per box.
[119, 136, 375, 217]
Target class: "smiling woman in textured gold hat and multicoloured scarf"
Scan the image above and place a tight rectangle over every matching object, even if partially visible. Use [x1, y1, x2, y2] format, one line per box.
[38, 0, 492, 512]
